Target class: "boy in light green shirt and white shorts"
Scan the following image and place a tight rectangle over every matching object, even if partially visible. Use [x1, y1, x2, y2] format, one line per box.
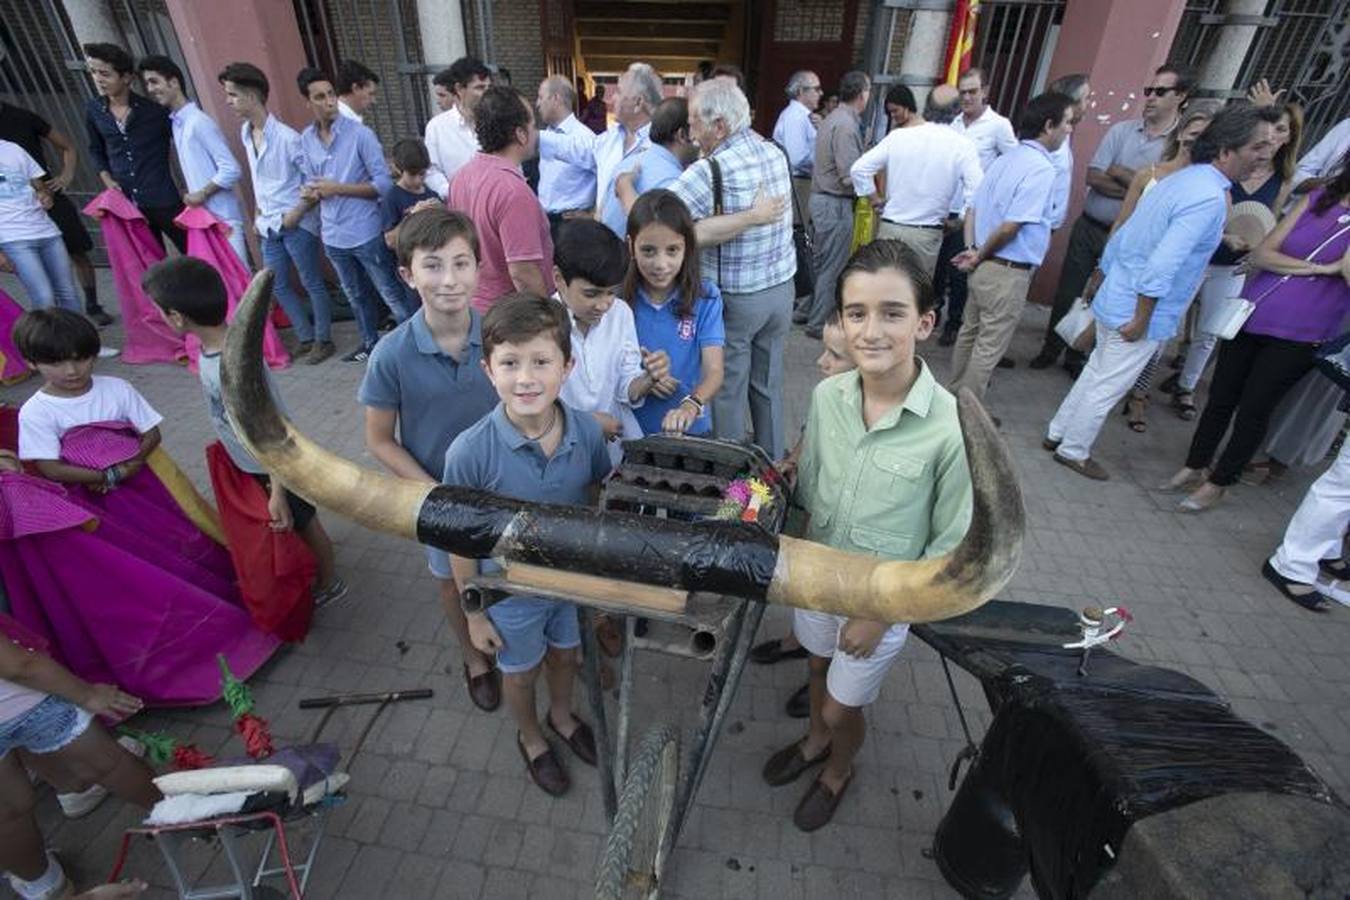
[764, 240, 972, 831]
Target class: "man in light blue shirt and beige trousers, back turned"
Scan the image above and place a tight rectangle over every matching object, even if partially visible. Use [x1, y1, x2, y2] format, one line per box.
[952, 92, 1073, 398]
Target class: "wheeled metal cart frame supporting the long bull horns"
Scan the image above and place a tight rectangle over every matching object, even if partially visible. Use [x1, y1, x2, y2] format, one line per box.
[462, 436, 787, 899]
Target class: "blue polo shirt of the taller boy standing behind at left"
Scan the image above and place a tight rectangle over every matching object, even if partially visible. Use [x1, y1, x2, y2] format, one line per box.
[356, 309, 497, 478]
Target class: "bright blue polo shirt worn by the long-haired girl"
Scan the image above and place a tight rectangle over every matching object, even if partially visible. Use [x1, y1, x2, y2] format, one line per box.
[633, 278, 726, 434]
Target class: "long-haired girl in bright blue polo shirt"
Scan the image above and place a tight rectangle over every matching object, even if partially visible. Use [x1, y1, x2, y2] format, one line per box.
[624, 189, 726, 434]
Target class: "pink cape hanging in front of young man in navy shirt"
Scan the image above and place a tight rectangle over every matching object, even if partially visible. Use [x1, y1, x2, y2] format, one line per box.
[84, 190, 188, 363]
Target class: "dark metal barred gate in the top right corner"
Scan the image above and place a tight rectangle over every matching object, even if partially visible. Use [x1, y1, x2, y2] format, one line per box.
[1169, 0, 1350, 147]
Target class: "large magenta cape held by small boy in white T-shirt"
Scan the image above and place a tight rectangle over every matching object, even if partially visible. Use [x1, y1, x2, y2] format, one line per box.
[0, 426, 278, 706]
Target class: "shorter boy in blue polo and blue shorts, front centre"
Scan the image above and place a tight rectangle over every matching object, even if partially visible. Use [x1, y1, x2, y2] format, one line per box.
[441, 294, 610, 796]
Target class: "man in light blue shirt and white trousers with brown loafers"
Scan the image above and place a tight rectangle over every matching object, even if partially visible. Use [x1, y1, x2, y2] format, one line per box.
[1045, 107, 1280, 480]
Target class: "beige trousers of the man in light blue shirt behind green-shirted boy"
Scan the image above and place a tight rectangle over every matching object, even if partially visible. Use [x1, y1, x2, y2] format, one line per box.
[952, 260, 1031, 399]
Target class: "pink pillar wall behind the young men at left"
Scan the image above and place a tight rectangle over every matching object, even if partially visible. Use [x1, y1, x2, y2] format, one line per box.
[167, 0, 309, 260]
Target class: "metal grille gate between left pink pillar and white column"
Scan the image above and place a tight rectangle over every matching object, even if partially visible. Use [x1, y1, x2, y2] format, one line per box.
[294, 0, 432, 148]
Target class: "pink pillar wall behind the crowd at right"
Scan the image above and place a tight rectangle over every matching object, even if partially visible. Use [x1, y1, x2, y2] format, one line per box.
[1031, 0, 1185, 304]
